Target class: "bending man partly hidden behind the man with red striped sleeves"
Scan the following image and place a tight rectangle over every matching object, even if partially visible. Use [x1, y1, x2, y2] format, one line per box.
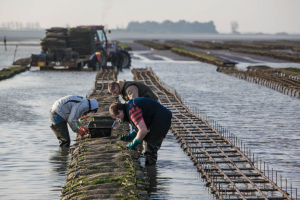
[108, 79, 158, 101]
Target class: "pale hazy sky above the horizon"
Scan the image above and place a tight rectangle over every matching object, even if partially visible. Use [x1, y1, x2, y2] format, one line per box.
[0, 0, 300, 33]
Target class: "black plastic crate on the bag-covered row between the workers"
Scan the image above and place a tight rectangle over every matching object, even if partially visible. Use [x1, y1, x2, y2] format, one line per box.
[88, 120, 115, 138]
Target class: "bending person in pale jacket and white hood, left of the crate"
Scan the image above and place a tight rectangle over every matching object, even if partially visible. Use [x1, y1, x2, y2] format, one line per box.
[50, 95, 98, 147]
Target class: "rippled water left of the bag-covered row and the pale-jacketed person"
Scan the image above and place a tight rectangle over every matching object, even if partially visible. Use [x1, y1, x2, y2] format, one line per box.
[0, 65, 96, 199]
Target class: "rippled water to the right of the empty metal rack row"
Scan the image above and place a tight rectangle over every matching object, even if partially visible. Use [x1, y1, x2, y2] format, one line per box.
[122, 52, 300, 197]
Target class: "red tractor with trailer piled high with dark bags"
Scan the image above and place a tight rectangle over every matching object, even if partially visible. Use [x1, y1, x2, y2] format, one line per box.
[30, 26, 131, 70]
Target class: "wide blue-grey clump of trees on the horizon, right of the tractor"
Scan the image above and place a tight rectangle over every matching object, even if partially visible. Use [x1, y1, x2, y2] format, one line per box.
[125, 20, 218, 34]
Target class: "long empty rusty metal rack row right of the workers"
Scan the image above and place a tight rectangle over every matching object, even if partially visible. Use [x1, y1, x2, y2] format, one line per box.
[132, 69, 297, 200]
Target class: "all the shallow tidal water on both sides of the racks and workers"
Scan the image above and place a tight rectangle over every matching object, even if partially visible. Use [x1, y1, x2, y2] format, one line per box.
[0, 44, 300, 200]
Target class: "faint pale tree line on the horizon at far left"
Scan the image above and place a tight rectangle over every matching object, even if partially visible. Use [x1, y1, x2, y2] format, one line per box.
[0, 21, 41, 30]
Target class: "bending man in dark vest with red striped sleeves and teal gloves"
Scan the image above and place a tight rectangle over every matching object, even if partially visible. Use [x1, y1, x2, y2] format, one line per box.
[109, 97, 172, 165]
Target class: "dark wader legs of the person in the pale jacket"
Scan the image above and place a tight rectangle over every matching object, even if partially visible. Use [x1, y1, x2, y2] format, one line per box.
[50, 122, 71, 147]
